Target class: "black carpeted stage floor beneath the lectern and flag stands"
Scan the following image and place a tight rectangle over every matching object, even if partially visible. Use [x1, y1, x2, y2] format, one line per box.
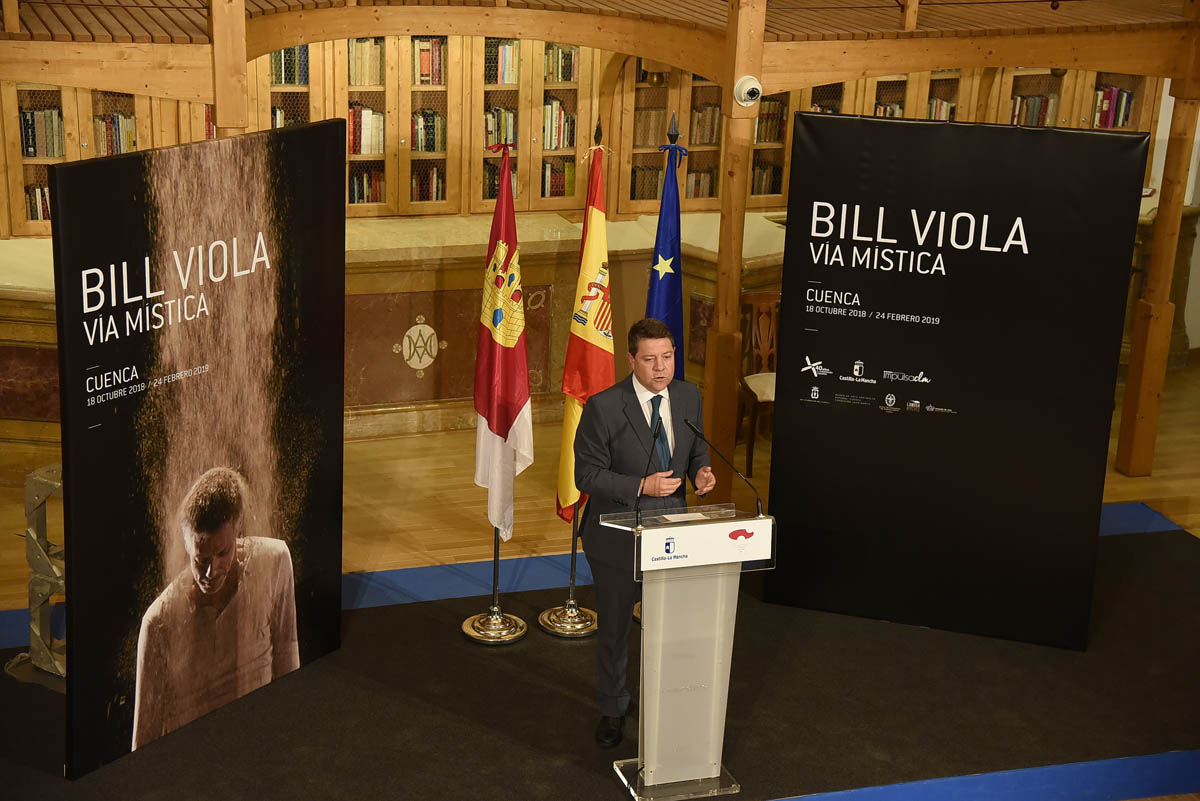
[0, 531, 1200, 801]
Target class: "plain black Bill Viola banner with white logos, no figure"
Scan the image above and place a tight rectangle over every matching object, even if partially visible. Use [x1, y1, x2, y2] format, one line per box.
[767, 114, 1147, 648]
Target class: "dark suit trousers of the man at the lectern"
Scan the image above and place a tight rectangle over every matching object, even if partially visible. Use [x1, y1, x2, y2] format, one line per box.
[590, 560, 642, 717]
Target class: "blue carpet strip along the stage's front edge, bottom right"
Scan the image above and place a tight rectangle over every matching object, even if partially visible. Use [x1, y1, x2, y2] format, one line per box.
[784, 751, 1200, 801]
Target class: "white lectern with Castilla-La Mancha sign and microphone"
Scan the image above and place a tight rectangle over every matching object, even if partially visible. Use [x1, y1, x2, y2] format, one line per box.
[600, 504, 775, 801]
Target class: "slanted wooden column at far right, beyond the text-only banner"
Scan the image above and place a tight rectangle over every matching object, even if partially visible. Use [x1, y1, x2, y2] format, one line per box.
[1116, 89, 1200, 476]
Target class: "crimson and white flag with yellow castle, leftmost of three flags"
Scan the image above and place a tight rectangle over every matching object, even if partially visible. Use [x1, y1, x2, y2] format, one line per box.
[475, 145, 533, 540]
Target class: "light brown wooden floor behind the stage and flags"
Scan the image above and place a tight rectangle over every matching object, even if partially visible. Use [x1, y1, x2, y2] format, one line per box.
[0, 366, 1200, 609]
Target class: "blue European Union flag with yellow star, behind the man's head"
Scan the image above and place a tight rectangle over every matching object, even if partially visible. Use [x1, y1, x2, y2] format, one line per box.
[646, 145, 688, 380]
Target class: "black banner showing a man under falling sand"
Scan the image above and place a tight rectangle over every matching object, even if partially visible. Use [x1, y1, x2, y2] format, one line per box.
[50, 121, 346, 776]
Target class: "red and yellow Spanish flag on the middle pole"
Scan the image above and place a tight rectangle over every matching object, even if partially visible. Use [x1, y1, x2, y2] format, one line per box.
[557, 146, 614, 522]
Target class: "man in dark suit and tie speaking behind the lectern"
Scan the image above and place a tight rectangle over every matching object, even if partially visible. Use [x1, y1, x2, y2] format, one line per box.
[575, 319, 716, 748]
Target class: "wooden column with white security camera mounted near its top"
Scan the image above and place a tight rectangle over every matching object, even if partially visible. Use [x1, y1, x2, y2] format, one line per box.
[704, 0, 767, 504]
